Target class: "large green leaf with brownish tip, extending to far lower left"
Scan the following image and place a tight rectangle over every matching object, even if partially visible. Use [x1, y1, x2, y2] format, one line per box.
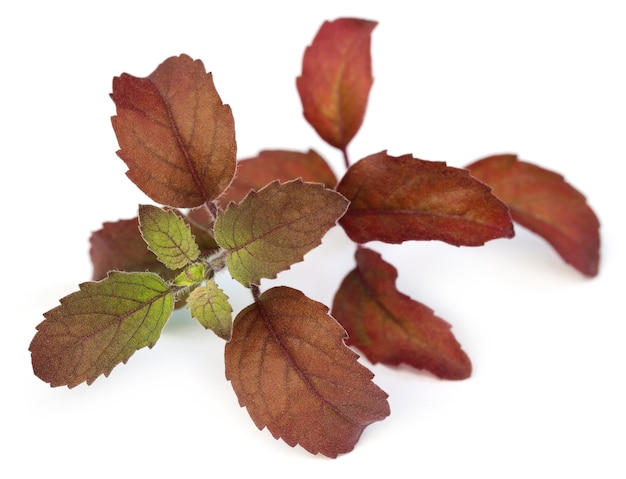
[30, 272, 174, 388]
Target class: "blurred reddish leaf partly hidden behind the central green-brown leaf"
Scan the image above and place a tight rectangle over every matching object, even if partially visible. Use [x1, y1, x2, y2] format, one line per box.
[219, 150, 337, 206]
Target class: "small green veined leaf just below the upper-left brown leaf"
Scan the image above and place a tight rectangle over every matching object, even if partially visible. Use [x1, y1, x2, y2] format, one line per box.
[139, 205, 200, 269]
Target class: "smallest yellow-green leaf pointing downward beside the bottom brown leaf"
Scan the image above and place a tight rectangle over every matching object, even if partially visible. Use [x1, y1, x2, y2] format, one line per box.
[187, 279, 233, 341]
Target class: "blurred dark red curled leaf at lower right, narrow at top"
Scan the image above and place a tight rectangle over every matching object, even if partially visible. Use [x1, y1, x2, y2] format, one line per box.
[332, 247, 472, 379]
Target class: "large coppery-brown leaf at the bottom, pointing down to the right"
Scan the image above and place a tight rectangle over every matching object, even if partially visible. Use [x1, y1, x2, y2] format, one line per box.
[225, 286, 389, 457]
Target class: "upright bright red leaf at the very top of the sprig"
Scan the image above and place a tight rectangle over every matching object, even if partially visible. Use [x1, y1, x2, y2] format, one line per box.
[296, 18, 376, 150]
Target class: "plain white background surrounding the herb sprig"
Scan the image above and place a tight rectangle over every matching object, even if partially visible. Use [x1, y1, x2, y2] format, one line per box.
[0, 0, 626, 479]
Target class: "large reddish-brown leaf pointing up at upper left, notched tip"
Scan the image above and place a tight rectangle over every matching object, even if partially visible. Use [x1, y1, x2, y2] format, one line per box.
[111, 55, 236, 208]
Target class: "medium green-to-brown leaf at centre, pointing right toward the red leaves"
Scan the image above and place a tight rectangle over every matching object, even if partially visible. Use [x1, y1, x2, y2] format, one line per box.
[214, 179, 348, 286]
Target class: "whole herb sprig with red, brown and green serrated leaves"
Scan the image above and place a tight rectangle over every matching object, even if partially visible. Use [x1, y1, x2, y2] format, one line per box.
[30, 18, 600, 457]
